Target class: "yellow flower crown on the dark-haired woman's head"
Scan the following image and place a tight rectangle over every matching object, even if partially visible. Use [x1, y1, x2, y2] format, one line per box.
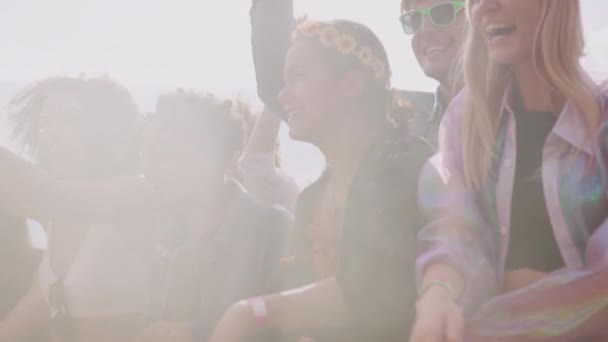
[291, 20, 389, 80]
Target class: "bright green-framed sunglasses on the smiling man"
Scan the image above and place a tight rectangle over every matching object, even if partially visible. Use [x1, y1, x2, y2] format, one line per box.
[399, 1, 465, 34]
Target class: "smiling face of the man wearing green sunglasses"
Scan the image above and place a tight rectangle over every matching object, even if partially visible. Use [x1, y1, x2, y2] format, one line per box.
[407, 0, 465, 82]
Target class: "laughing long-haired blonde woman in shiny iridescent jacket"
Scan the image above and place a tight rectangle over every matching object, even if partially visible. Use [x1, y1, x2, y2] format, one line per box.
[412, 0, 608, 341]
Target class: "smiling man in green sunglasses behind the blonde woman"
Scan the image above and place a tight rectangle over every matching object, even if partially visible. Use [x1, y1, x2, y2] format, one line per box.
[399, 0, 466, 144]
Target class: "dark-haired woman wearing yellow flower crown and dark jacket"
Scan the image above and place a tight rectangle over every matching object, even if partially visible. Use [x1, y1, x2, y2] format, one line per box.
[211, 20, 431, 342]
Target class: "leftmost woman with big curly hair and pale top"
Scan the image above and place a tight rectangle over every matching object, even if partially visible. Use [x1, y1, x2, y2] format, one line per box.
[0, 77, 151, 342]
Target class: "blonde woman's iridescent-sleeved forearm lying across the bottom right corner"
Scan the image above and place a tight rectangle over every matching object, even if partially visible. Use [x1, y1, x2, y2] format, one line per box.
[471, 269, 608, 340]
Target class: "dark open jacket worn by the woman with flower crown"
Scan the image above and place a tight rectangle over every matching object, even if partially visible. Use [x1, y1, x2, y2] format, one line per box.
[286, 133, 432, 341]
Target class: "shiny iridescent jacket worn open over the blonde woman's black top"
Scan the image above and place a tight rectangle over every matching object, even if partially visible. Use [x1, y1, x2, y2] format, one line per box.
[417, 81, 608, 340]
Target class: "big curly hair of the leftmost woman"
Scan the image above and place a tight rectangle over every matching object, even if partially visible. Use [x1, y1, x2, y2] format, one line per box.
[8, 77, 139, 174]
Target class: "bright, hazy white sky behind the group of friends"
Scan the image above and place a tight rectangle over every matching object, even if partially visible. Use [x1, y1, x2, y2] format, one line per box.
[0, 0, 608, 183]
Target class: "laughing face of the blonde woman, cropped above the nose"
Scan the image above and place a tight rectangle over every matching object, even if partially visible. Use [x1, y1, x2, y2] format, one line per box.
[470, 0, 542, 65]
